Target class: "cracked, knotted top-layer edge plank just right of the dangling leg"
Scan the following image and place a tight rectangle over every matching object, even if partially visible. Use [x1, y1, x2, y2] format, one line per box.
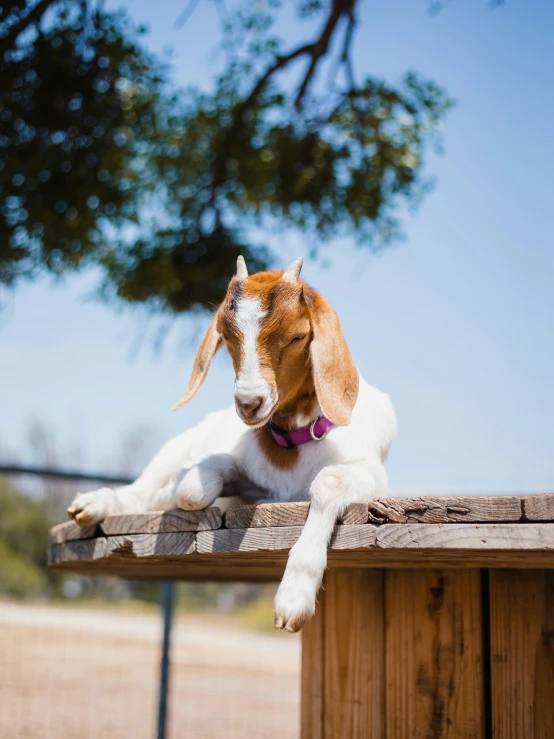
[369, 496, 522, 523]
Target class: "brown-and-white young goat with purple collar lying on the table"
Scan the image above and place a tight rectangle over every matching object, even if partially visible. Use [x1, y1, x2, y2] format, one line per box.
[68, 257, 396, 632]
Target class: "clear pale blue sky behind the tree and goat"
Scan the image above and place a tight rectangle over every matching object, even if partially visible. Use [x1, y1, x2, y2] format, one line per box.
[0, 0, 554, 493]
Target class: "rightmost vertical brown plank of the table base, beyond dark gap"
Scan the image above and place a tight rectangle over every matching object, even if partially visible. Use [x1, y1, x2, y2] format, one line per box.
[490, 570, 554, 739]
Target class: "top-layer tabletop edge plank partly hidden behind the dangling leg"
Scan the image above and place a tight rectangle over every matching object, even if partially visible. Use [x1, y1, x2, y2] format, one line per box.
[224, 501, 368, 529]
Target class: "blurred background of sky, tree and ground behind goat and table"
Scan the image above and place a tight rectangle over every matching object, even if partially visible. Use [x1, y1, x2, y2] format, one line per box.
[0, 0, 554, 739]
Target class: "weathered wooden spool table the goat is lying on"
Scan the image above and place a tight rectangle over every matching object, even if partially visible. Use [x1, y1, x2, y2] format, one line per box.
[50, 495, 554, 739]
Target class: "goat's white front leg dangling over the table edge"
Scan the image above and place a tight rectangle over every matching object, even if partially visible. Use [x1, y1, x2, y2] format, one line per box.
[275, 462, 387, 632]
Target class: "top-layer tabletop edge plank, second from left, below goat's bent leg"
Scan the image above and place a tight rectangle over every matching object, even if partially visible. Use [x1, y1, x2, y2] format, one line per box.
[100, 507, 222, 536]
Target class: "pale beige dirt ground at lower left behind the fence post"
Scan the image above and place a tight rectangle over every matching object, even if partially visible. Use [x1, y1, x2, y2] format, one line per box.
[0, 602, 300, 739]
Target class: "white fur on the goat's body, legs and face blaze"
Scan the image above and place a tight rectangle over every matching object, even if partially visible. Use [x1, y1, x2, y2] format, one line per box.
[69, 378, 396, 630]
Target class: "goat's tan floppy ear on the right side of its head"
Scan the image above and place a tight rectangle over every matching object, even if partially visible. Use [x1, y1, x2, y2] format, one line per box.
[308, 292, 360, 426]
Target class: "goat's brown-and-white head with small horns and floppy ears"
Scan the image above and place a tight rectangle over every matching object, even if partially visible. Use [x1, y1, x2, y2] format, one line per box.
[174, 257, 358, 427]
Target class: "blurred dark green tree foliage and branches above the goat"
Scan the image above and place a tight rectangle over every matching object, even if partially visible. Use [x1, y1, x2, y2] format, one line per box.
[0, 0, 451, 312]
